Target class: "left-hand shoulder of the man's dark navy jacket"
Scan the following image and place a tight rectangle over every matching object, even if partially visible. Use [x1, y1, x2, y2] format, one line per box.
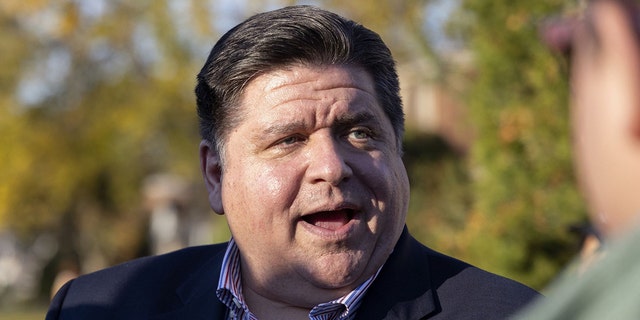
[47, 243, 226, 319]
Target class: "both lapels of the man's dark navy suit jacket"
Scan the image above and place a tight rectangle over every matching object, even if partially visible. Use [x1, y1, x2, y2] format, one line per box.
[151, 227, 439, 320]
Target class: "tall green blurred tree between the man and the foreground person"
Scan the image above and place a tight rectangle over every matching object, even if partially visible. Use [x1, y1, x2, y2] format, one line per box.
[450, 0, 585, 288]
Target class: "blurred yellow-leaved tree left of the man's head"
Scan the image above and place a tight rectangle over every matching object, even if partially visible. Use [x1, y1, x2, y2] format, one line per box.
[0, 1, 232, 290]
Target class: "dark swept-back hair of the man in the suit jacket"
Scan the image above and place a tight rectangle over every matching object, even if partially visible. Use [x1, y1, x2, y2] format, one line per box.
[195, 6, 404, 158]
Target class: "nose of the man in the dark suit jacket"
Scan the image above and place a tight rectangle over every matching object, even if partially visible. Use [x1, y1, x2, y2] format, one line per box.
[307, 137, 353, 186]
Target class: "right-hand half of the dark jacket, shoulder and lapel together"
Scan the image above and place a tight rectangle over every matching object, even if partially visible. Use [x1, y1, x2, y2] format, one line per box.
[358, 231, 539, 319]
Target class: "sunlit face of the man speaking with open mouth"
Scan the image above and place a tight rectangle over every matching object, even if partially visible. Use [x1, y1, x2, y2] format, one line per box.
[205, 66, 409, 299]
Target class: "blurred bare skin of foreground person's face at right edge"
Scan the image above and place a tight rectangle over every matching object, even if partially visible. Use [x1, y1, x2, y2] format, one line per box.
[571, 1, 640, 235]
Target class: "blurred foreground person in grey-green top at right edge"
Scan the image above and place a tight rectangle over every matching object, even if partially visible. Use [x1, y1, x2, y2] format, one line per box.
[519, 0, 640, 320]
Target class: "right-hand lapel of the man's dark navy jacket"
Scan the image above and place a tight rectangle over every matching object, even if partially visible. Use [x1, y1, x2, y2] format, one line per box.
[356, 227, 439, 320]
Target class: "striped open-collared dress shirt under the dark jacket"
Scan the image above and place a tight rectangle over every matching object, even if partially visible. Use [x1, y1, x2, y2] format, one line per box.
[216, 238, 382, 320]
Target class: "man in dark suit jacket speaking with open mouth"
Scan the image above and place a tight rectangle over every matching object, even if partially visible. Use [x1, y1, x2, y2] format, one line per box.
[48, 6, 538, 320]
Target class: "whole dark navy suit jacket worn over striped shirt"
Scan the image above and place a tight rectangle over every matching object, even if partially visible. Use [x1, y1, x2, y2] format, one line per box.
[46, 228, 539, 320]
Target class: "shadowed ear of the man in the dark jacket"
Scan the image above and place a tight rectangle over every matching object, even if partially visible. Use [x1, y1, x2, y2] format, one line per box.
[200, 140, 224, 214]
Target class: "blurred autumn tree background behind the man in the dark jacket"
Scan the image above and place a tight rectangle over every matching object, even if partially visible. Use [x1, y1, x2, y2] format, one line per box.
[0, 0, 587, 319]
